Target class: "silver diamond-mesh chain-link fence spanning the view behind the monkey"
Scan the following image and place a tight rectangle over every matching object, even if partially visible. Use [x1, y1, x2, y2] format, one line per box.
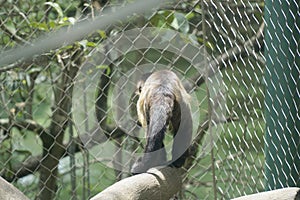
[0, 0, 300, 199]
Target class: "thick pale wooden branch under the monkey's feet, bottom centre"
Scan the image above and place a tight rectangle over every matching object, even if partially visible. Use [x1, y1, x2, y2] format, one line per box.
[91, 167, 184, 200]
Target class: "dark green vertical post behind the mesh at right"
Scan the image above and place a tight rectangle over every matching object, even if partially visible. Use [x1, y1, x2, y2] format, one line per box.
[264, 0, 300, 190]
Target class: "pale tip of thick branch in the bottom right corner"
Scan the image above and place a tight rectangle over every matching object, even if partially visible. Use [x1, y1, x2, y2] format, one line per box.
[233, 187, 300, 200]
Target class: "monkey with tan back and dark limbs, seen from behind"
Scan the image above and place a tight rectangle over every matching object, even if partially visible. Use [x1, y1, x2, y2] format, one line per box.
[131, 70, 193, 174]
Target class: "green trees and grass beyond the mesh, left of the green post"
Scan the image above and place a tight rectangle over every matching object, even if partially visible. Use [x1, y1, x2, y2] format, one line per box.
[0, 0, 265, 199]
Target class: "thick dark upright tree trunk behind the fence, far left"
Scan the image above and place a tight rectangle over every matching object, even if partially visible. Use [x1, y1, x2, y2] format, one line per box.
[37, 46, 83, 200]
